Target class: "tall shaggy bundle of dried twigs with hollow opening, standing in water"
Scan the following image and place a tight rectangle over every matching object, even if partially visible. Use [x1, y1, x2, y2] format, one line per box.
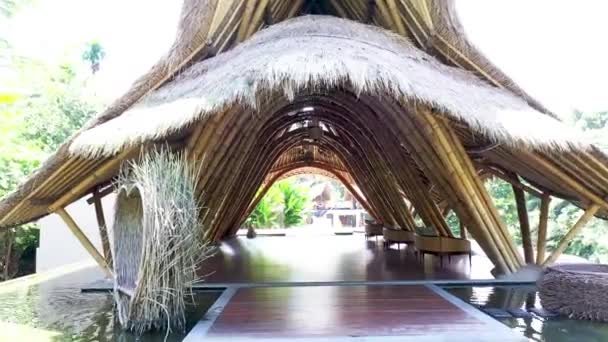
[112, 149, 211, 333]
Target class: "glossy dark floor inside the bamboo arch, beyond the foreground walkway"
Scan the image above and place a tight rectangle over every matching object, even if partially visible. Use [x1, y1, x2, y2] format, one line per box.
[199, 233, 493, 283]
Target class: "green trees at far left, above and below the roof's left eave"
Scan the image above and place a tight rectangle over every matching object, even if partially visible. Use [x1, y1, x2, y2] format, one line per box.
[0, 37, 99, 280]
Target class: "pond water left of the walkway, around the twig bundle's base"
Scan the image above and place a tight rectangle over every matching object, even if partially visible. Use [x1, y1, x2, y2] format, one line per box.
[0, 267, 220, 342]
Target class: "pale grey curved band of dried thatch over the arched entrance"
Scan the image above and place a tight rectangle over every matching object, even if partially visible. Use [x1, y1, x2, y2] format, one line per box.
[70, 16, 581, 157]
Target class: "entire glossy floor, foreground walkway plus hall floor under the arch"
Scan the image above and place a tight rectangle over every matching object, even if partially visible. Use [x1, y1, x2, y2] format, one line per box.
[184, 234, 523, 342]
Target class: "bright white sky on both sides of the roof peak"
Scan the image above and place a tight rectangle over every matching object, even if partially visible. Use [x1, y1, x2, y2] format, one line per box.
[0, 0, 608, 115]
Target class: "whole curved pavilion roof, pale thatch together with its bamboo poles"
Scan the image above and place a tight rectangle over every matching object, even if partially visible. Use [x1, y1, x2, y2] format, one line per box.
[0, 0, 608, 271]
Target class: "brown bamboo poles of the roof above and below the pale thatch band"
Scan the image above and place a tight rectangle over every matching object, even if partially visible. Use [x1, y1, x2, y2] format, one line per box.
[0, 0, 608, 272]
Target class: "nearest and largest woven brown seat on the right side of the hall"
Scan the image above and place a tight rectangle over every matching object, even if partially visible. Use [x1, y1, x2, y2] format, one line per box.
[414, 235, 472, 265]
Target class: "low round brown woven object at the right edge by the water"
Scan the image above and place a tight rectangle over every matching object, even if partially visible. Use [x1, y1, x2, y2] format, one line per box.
[538, 264, 608, 322]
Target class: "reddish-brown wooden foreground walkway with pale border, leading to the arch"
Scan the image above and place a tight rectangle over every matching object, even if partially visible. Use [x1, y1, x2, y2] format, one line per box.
[184, 285, 523, 342]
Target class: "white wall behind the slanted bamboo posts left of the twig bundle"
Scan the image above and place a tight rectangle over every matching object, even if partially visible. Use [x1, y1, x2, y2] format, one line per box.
[36, 194, 115, 272]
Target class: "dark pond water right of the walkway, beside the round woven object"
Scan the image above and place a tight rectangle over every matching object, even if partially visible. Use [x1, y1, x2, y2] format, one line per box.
[446, 286, 608, 342]
